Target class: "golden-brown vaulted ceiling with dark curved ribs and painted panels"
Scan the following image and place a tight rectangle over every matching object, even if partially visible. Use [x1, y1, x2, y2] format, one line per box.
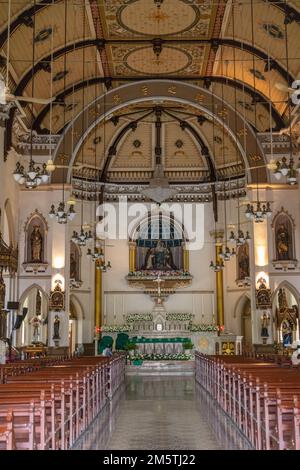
[0, 0, 300, 182]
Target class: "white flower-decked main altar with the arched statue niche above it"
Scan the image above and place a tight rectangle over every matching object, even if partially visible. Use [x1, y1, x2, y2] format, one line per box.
[101, 215, 242, 360]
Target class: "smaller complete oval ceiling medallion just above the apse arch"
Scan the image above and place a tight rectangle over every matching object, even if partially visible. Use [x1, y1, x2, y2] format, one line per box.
[124, 46, 192, 75]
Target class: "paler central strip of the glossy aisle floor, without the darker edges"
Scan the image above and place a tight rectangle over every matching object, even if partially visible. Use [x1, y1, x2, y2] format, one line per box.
[107, 376, 220, 450]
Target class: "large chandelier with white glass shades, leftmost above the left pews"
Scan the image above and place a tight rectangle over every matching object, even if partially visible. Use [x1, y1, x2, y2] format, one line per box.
[13, 158, 50, 189]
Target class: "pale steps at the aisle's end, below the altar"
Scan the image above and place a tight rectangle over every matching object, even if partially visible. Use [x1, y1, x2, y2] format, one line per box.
[126, 361, 195, 375]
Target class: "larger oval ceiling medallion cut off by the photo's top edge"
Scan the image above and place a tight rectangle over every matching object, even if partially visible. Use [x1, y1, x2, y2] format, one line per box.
[117, 0, 200, 36]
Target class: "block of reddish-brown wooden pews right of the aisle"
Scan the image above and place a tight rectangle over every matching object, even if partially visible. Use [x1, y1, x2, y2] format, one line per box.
[195, 353, 300, 450]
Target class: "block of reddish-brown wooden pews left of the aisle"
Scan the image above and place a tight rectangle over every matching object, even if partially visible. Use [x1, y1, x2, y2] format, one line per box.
[0, 354, 125, 450]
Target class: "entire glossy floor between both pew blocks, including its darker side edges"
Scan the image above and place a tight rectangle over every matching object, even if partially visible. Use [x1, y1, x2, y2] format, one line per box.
[74, 376, 251, 450]
